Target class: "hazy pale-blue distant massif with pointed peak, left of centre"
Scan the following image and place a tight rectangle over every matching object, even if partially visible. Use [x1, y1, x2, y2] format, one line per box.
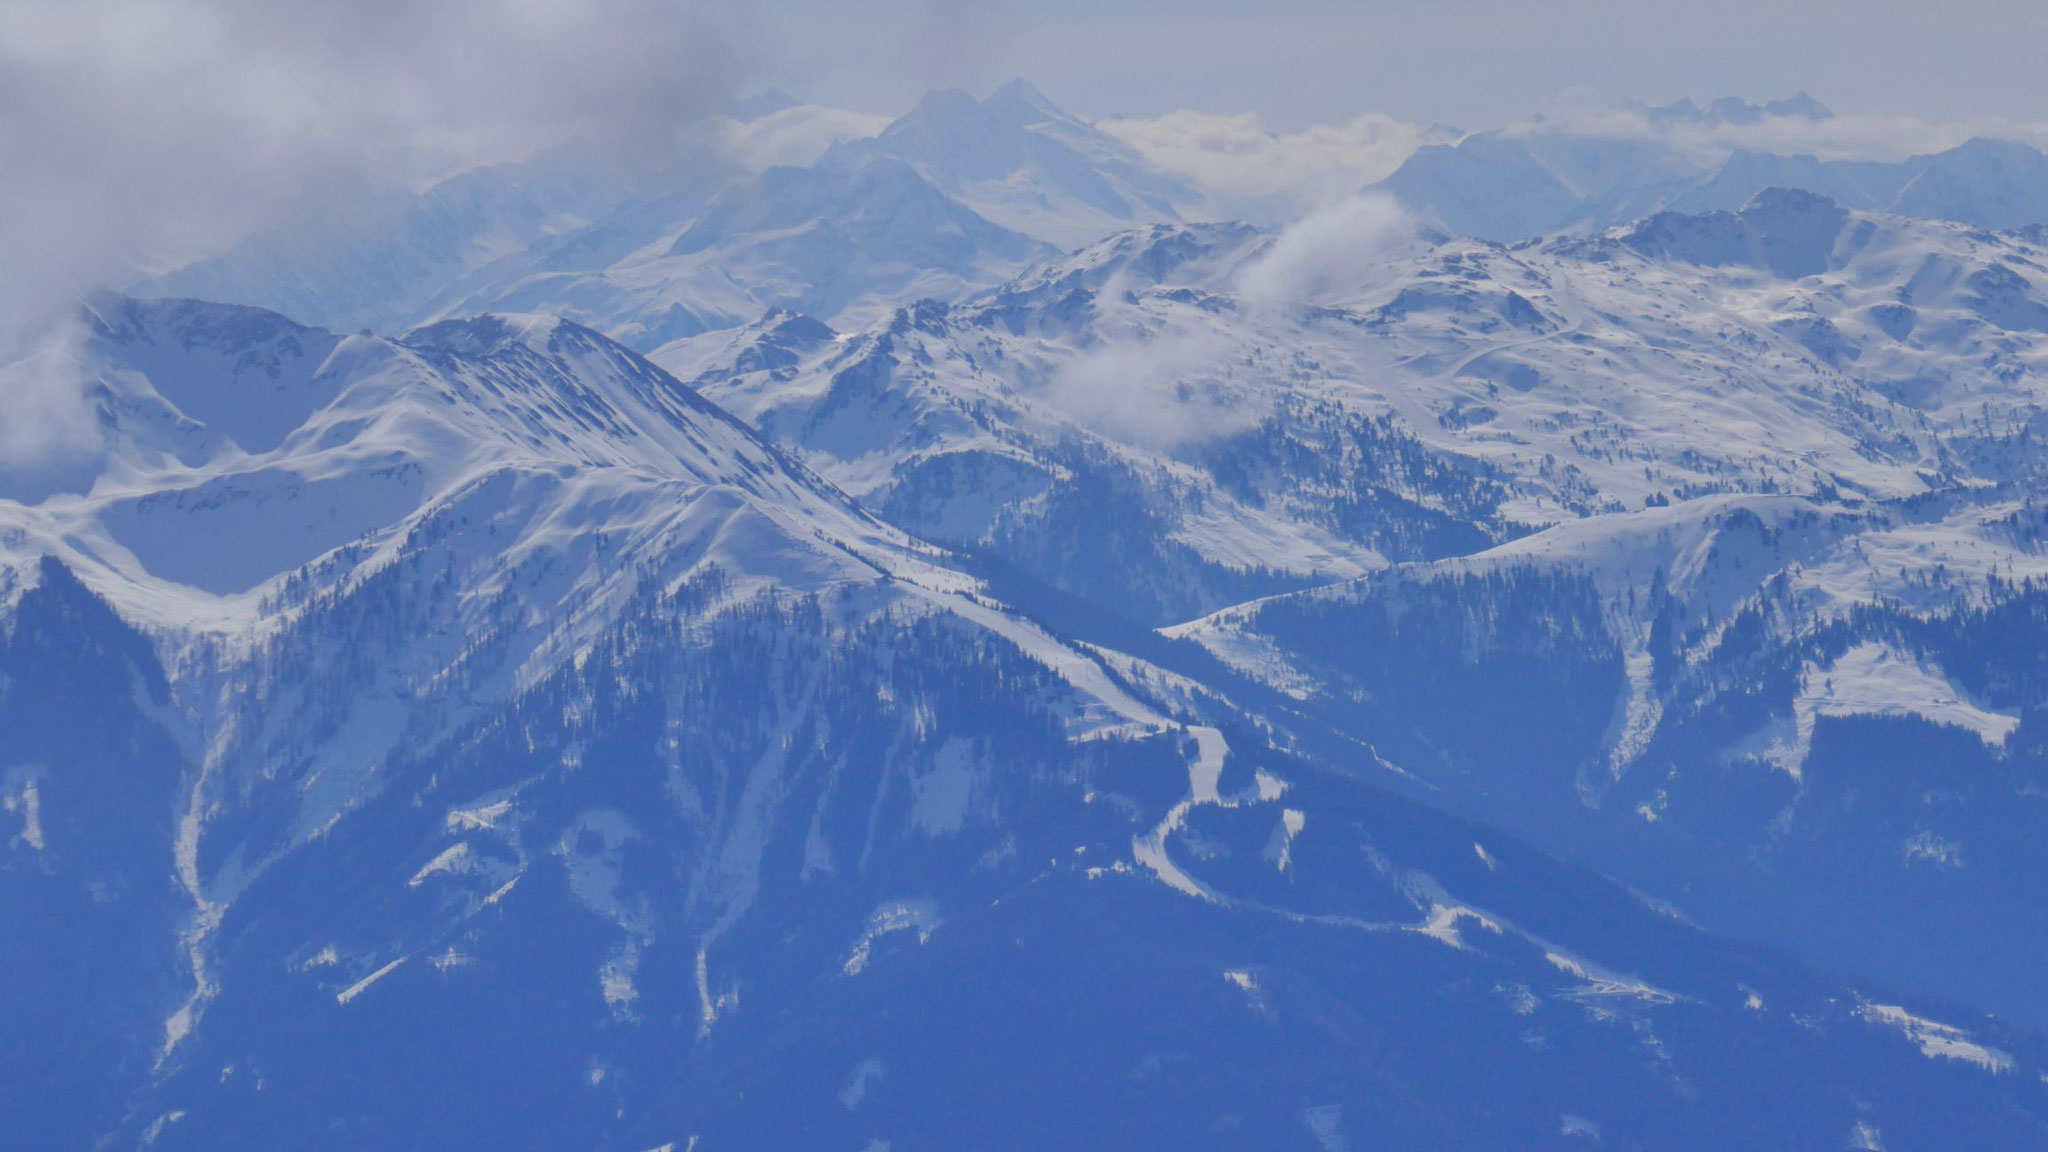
[133, 80, 1200, 351]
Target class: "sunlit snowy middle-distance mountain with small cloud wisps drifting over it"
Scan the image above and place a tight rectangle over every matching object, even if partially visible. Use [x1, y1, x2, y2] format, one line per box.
[655, 191, 2048, 619]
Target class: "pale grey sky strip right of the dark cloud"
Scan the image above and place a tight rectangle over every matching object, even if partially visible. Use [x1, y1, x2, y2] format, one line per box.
[766, 0, 2048, 127]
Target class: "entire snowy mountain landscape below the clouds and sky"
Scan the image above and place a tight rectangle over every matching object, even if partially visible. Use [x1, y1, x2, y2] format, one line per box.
[0, 31, 2048, 1152]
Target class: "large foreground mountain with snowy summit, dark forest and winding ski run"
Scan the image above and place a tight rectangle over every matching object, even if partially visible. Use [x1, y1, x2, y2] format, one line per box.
[0, 293, 2048, 1148]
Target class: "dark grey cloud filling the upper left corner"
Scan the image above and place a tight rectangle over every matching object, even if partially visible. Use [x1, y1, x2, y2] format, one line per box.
[0, 0, 750, 327]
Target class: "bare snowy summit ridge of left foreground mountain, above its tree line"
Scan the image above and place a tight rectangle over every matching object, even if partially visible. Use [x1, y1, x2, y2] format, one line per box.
[0, 297, 901, 614]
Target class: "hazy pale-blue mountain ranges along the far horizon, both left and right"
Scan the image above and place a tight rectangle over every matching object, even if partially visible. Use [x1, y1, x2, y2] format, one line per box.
[144, 80, 2048, 342]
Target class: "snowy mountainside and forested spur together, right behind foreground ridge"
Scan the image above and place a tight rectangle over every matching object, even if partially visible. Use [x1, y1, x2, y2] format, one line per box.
[657, 191, 2048, 1041]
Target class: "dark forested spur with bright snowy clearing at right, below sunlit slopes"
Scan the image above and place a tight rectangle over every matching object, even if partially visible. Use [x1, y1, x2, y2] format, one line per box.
[1174, 477, 2048, 1021]
